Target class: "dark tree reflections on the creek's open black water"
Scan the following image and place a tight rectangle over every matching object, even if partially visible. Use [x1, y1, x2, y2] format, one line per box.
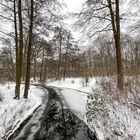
[38, 94, 97, 140]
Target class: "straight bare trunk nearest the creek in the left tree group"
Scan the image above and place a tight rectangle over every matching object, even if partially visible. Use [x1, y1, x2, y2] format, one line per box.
[24, 0, 34, 98]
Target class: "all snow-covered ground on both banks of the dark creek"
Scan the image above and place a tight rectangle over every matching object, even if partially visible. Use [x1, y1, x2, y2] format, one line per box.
[0, 77, 140, 140]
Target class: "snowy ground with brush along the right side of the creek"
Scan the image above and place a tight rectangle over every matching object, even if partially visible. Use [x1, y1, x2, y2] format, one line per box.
[47, 77, 140, 140]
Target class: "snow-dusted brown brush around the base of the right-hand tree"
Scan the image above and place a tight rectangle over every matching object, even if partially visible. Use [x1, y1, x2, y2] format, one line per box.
[86, 78, 140, 140]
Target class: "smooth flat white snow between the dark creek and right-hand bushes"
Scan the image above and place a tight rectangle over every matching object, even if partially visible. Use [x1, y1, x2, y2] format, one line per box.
[47, 77, 98, 119]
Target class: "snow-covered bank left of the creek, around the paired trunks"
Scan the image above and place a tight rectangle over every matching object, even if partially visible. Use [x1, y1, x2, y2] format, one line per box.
[0, 83, 44, 139]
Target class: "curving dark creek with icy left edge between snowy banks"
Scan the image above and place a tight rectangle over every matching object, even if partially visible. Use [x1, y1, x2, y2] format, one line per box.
[8, 86, 98, 140]
